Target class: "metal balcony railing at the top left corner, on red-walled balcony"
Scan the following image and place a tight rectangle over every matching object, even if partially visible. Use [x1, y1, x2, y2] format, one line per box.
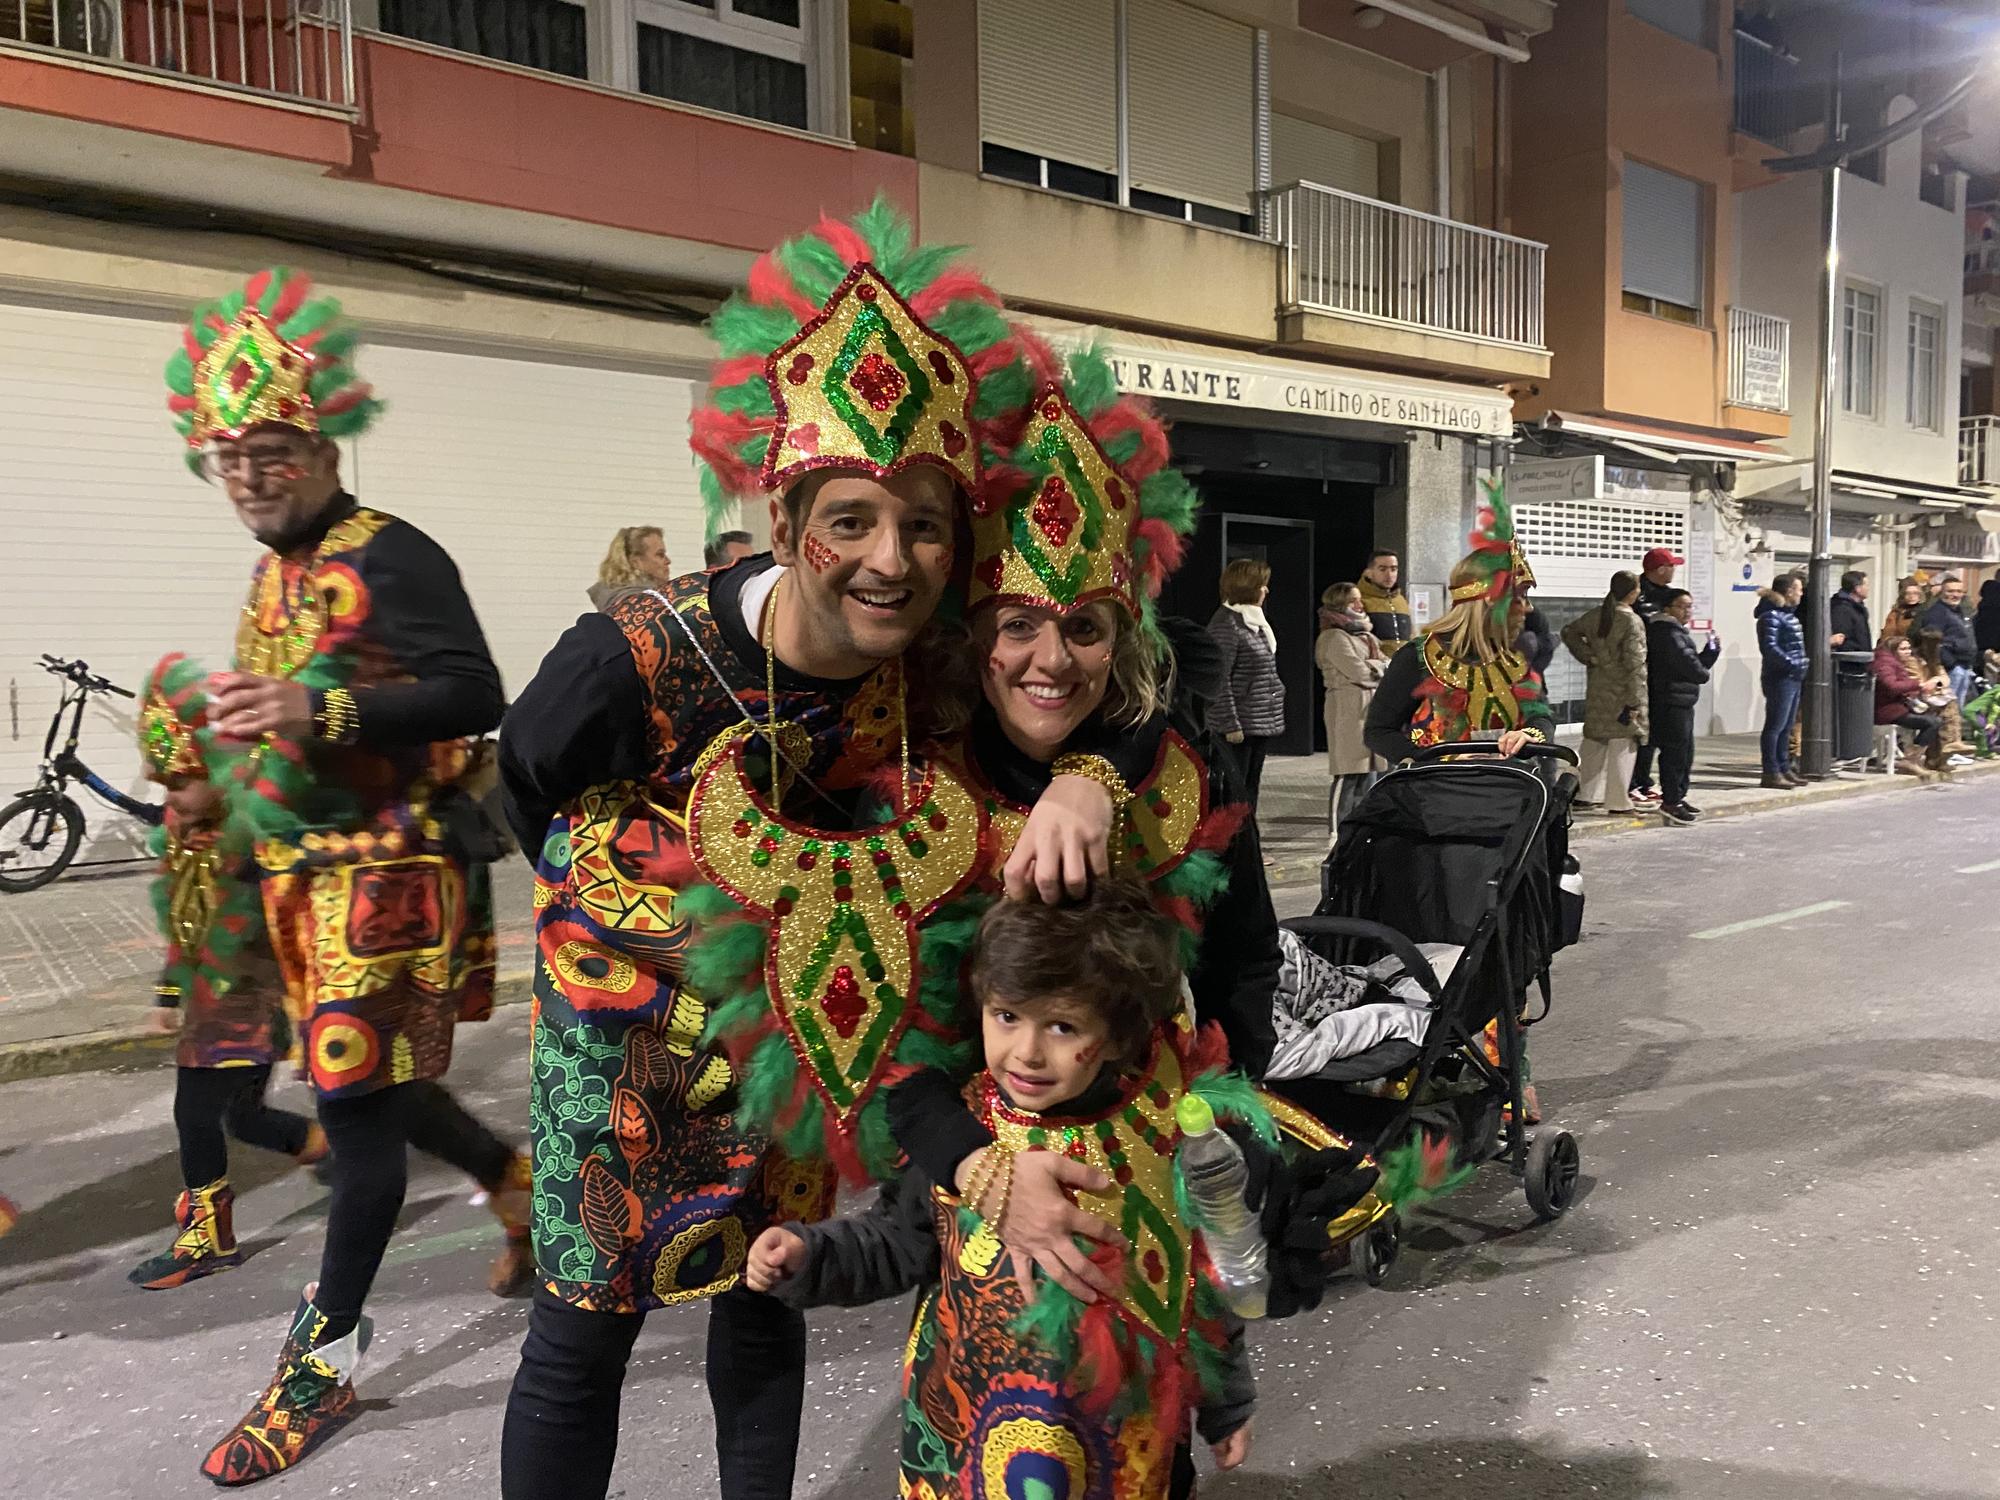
[0, 0, 354, 108]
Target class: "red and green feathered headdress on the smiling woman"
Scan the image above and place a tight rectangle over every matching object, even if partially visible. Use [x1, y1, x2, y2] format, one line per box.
[968, 336, 1200, 628]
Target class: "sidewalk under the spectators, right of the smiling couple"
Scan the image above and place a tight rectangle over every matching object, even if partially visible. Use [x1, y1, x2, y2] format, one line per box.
[1258, 734, 2000, 916]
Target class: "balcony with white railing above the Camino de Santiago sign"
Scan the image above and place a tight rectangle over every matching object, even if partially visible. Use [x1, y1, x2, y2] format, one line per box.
[1264, 182, 1548, 376]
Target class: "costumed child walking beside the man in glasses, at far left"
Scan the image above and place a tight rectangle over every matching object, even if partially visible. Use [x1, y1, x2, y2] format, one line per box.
[128, 656, 326, 1292]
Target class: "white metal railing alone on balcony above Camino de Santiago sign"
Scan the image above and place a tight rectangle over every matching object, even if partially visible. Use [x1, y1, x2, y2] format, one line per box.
[1264, 182, 1548, 350]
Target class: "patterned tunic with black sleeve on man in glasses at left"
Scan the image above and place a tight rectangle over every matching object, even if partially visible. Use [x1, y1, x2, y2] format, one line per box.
[236, 500, 498, 1098]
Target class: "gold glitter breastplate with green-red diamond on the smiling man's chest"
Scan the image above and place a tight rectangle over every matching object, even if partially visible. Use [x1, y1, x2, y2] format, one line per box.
[688, 740, 980, 1130]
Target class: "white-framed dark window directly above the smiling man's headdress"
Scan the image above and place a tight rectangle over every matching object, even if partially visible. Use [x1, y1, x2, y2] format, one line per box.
[636, 0, 810, 130]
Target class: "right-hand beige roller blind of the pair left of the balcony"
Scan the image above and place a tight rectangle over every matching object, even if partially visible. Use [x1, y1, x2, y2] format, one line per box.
[1126, 0, 1256, 214]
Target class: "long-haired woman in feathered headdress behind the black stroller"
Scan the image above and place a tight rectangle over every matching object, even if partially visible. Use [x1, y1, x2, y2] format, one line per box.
[1366, 484, 1556, 766]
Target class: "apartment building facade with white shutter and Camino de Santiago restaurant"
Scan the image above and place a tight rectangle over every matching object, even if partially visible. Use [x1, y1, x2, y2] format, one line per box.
[0, 0, 1554, 828]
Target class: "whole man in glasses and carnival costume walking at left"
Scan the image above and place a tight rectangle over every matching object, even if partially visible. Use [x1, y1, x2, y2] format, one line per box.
[162, 270, 528, 1486]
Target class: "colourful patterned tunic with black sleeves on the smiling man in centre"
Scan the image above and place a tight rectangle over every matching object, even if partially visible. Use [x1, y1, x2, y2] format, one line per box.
[502, 560, 900, 1312]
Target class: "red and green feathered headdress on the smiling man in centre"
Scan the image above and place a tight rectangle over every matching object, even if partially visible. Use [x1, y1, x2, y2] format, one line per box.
[690, 198, 1028, 536]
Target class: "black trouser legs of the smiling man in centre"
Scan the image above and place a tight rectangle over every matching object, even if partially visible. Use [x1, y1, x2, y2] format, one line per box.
[500, 1286, 806, 1500]
